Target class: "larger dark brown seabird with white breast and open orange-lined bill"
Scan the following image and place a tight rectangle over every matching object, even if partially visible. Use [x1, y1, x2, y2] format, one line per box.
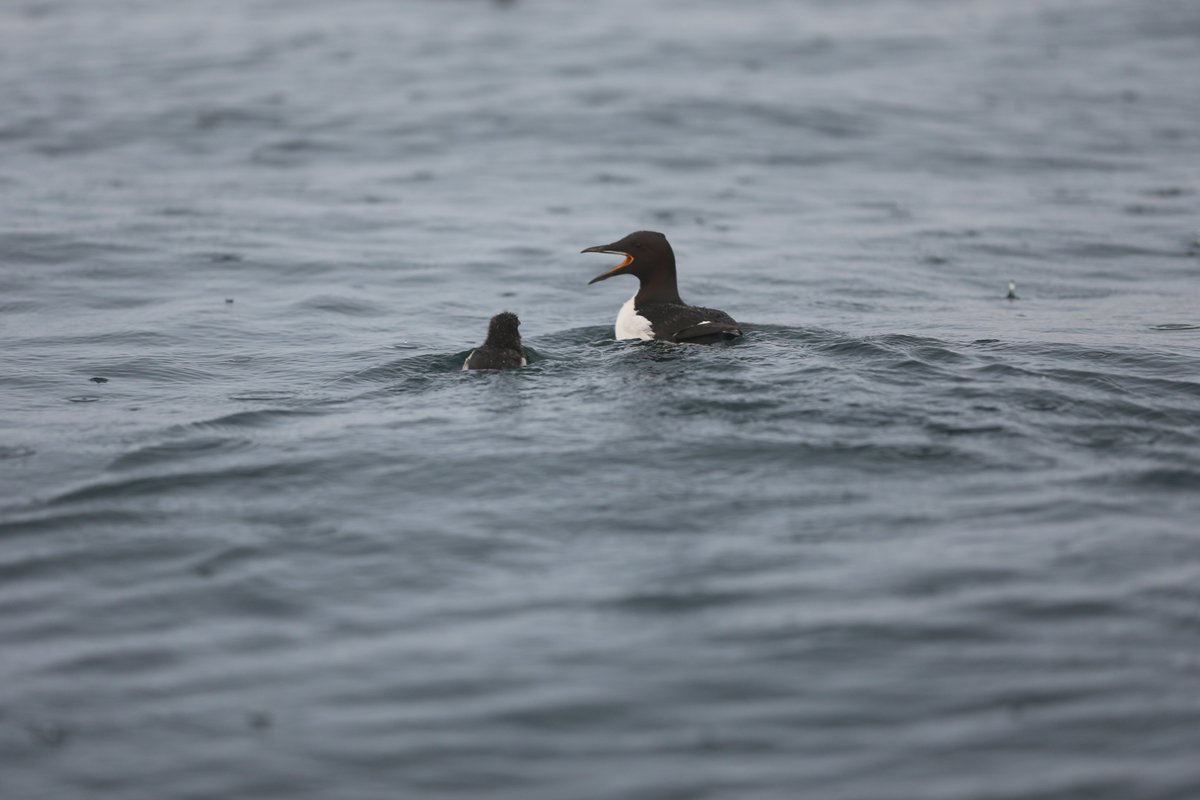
[581, 230, 742, 344]
